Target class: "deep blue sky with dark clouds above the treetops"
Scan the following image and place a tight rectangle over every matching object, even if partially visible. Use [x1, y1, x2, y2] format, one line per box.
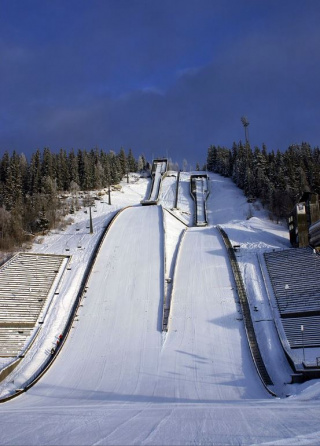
[0, 0, 320, 164]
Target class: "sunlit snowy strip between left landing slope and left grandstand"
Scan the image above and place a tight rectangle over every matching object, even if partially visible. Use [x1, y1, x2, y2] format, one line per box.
[0, 174, 150, 380]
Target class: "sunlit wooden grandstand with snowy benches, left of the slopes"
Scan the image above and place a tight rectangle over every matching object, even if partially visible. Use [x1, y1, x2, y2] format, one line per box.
[0, 253, 69, 357]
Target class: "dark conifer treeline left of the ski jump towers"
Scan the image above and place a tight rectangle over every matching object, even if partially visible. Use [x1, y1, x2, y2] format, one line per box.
[0, 148, 148, 250]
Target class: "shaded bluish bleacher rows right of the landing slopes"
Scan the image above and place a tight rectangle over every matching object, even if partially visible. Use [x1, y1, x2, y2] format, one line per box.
[264, 248, 320, 348]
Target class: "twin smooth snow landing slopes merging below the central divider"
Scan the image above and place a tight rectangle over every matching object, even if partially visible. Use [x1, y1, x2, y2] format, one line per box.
[3, 207, 265, 406]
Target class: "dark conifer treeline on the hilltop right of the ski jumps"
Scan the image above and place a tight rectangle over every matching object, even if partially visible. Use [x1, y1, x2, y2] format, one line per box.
[207, 143, 320, 218]
